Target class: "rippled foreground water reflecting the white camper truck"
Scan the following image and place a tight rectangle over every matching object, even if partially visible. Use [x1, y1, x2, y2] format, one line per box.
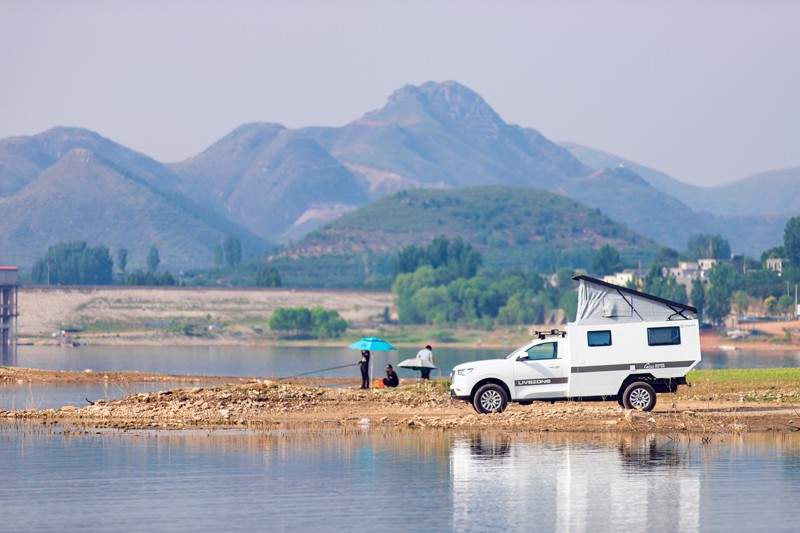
[0, 422, 800, 532]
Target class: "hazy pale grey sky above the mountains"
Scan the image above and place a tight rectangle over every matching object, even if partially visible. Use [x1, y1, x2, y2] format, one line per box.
[0, 0, 800, 185]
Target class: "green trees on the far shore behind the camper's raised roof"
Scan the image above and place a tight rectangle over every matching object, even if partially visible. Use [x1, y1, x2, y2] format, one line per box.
[392, 217, 800, 328]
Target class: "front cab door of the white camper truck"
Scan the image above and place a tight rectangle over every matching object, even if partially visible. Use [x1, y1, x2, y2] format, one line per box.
[513, 341, 569, 400]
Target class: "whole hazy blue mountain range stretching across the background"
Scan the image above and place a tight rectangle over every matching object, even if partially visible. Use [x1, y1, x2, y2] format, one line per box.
[0, 82, 800, 268]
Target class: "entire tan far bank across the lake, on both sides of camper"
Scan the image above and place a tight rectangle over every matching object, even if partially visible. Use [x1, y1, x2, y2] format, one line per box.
[17, 287, 800, 352]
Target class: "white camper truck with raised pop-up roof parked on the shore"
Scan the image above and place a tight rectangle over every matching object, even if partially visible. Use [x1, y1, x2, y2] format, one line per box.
[450, 276, 700, 413]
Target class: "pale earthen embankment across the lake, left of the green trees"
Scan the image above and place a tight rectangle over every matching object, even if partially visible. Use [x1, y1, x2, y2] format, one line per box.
[17, 287, 392, 344]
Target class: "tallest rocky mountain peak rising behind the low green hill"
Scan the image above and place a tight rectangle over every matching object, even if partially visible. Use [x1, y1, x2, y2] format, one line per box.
[304, 81, 589, 197]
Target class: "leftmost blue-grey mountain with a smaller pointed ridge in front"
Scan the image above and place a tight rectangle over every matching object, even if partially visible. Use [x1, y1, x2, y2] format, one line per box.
[0, 128, 269, 268]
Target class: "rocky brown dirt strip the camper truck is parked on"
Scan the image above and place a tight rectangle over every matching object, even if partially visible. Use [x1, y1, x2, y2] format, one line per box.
[0, 367, 800, 439]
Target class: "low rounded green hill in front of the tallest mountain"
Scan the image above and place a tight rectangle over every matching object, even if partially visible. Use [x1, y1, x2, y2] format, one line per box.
[269, 186, 658, 285]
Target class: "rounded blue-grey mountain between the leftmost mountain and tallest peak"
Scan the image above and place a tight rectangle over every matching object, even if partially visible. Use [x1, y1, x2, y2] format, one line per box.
[171, 124, 369, 241]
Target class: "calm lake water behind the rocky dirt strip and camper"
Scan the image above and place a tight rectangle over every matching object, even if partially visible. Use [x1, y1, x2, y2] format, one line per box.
[0, 346, 800, 409]
